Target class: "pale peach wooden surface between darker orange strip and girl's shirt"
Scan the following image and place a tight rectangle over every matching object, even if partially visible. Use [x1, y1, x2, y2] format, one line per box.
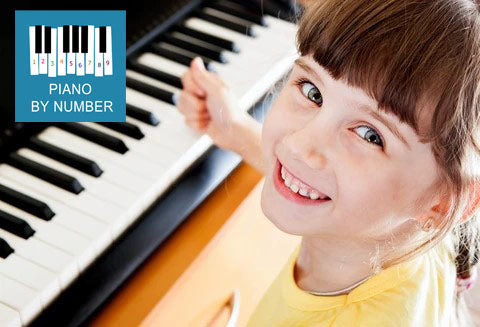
[141, 179, 301, 327]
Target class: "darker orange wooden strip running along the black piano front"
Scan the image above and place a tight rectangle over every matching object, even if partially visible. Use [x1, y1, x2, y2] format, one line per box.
[91, 162, 262, 327]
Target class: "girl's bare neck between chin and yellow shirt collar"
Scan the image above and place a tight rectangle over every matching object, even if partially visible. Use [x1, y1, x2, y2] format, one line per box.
[294, 236, 375, 294]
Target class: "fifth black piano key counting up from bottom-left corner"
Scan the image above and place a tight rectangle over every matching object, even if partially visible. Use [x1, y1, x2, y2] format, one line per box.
[27, 136, 103, 177]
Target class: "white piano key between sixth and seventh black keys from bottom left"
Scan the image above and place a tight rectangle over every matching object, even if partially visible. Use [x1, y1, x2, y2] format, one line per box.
[80, 122, 176, 172]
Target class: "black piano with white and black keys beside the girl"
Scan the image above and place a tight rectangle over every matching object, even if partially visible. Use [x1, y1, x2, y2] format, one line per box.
[0, 0, 298, 326]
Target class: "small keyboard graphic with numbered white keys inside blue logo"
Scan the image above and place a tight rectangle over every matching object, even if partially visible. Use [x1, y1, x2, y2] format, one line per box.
[29, 25, 113, 77]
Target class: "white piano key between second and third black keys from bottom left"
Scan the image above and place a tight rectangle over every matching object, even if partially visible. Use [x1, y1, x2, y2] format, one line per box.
[0, 201, 96, 270]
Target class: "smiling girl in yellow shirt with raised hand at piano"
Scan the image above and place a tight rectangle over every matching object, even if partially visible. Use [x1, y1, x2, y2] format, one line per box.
[178, 0, 480, 327]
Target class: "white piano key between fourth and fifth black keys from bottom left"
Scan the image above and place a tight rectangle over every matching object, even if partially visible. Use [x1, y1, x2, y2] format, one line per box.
[17, 148, 137, 208]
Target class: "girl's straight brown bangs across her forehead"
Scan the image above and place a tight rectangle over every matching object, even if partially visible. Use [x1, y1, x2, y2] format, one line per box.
[296, 0, 480, 143]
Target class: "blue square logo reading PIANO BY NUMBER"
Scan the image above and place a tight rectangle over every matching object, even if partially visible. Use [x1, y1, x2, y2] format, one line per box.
[15, 10, 126, 122]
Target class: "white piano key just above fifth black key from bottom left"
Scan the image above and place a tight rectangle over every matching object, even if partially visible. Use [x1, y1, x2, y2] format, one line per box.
[38, 128, 151, 192]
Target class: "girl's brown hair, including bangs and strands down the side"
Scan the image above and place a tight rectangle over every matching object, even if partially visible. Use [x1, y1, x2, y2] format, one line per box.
[284, 0, 480, 325]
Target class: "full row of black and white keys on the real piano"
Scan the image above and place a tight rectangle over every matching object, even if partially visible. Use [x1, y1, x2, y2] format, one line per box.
[5, 1, 297, 326]
